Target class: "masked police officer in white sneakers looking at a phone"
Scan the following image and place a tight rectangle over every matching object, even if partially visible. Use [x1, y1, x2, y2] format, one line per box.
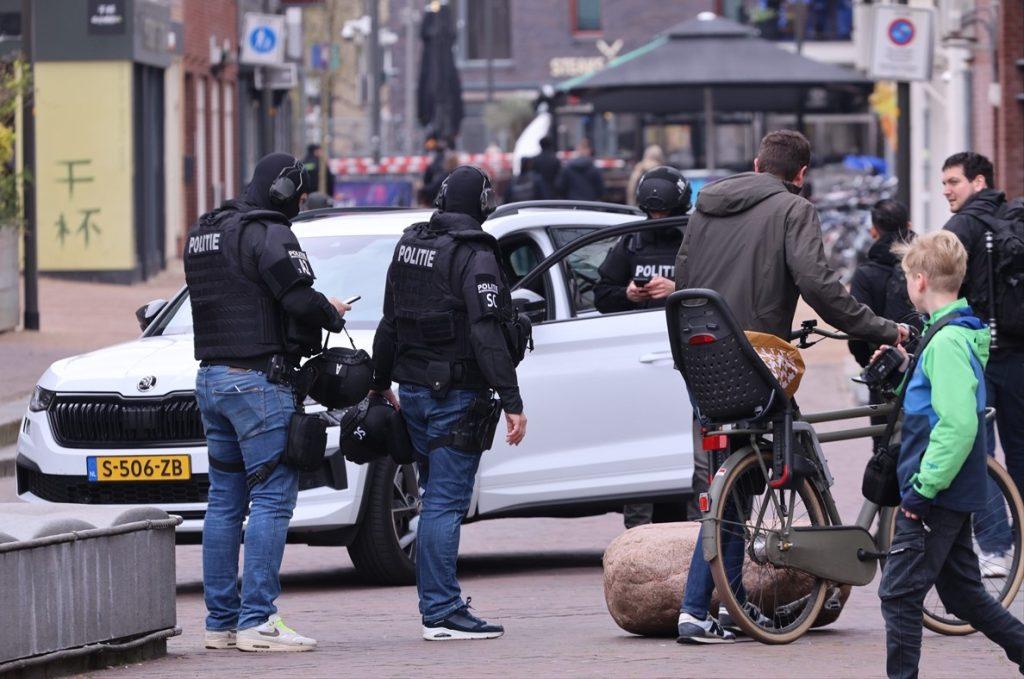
[184, 154, 349, 651]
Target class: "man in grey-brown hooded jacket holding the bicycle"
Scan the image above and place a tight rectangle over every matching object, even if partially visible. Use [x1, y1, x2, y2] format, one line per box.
[676, 130, 907, 643]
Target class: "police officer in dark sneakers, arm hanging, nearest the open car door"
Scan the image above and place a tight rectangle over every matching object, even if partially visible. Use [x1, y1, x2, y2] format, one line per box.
[374, 165, 526, 640]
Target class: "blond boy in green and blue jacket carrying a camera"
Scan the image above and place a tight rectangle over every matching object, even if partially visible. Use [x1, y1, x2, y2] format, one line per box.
[879, 231, 1024, 678]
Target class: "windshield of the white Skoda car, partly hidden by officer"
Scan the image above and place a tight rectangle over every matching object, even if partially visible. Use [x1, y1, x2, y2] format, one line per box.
[153, 236, 398, 335]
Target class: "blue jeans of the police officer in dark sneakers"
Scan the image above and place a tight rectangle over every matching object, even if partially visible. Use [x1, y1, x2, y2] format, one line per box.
[398, 384, 480, 625]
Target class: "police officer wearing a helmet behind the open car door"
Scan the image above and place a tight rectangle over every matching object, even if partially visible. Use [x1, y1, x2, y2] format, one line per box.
[594, 165, 690, 313]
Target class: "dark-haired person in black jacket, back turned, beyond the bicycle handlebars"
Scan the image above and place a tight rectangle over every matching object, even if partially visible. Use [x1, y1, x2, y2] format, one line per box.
[850, 199, 922, 368]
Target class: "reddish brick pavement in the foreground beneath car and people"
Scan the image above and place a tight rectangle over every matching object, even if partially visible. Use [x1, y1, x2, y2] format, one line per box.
[0, 311, 1024, 679]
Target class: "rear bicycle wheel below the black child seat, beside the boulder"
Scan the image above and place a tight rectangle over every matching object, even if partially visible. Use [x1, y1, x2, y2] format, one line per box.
[712, 451, 828, 644]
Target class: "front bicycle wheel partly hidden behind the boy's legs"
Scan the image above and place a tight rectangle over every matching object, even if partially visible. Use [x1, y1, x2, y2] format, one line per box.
[889, 457, 1024, 636]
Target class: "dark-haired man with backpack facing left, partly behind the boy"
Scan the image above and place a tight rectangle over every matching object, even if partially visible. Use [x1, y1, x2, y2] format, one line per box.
[942, 152, 1024, 578]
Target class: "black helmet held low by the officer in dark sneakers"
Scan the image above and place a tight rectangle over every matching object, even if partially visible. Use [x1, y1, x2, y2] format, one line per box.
[339, 393, 414, 464]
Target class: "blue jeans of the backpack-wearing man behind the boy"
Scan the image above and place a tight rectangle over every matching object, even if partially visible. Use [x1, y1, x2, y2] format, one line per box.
[974, 351, 1024, 554]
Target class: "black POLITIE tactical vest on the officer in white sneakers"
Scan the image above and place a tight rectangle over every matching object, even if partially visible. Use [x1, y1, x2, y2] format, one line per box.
[184, 210, 285, 360]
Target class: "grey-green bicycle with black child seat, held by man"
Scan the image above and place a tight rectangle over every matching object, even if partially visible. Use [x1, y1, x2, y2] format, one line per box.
[666, 289, 1024, 643]
